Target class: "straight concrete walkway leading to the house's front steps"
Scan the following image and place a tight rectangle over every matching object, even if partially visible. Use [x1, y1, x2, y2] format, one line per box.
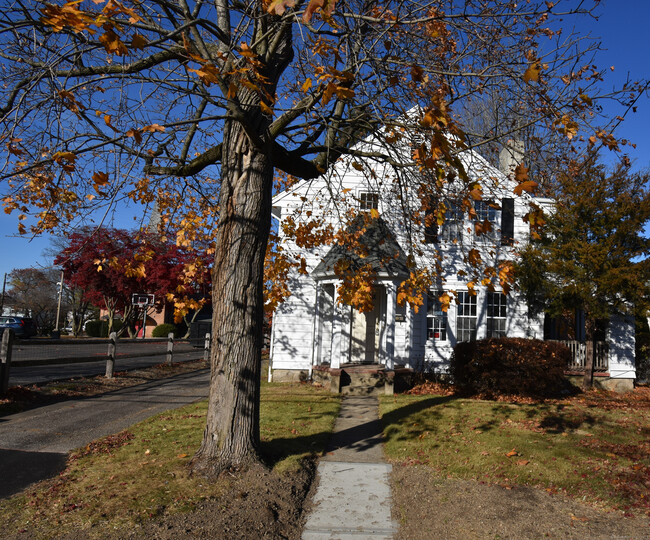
[302, 396, 397, 540]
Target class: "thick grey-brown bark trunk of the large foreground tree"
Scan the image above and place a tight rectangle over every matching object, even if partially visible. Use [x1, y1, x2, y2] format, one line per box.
[192, 115, 273, 476]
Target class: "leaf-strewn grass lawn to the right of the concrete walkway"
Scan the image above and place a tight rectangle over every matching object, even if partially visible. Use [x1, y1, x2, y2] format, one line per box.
[381, 389, 650, 515]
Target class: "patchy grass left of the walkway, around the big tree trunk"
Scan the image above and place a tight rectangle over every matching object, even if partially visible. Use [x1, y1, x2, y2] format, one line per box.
[0, 384, 339, 538]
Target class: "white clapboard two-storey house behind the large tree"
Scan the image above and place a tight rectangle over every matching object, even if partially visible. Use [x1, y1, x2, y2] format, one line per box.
[269, 138, 635, 389]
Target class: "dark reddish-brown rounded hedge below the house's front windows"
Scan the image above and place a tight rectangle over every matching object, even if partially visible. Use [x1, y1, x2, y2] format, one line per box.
[449, 338, 571, 397]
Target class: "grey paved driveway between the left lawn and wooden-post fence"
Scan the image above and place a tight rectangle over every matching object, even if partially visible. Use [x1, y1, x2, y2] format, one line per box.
[0, 369, 210, 498]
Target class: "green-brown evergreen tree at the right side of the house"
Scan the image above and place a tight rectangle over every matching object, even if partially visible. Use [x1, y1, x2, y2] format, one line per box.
[517, 155, 650, 387]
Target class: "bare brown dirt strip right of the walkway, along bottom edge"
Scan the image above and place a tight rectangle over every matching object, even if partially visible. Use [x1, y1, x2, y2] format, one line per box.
[392, 464, 650, 540]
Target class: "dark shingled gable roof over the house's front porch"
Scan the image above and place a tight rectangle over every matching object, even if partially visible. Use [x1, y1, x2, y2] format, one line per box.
[311, 215, 410, 280]
